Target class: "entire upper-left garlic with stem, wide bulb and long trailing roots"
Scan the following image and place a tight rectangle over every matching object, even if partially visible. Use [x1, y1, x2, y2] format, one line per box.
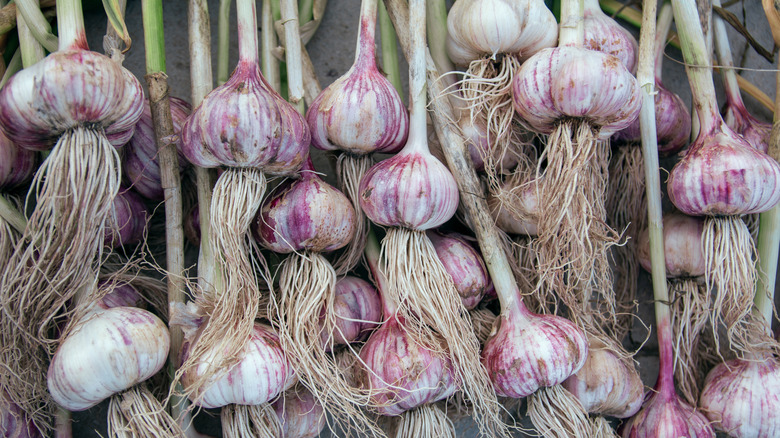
[0, 0, 143, 430]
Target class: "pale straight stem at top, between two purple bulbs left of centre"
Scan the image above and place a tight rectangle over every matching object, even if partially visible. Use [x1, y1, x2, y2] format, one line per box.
[281, 0, 305, 114]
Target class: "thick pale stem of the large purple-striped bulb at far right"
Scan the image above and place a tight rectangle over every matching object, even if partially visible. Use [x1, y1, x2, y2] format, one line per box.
[672, 0, 722, 134]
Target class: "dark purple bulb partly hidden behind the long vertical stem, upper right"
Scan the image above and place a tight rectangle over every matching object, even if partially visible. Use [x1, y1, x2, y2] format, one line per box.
[612, 82, 691, 156]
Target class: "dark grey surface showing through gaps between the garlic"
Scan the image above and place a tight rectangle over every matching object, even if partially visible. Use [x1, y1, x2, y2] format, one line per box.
[70, 0, 775, 437]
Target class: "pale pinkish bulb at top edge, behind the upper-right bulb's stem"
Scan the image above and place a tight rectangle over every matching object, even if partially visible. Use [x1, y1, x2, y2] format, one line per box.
[583, 0, 639, 73]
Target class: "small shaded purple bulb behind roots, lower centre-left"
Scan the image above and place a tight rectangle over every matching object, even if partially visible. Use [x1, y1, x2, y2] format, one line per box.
[323, 275, 382, 348]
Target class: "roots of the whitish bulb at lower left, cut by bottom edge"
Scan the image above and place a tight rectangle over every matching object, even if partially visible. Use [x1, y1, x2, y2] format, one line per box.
[108, 384, 185, 438]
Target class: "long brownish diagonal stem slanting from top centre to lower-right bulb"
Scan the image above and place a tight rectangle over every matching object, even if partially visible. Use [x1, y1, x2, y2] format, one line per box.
[385, 0, 525, 319]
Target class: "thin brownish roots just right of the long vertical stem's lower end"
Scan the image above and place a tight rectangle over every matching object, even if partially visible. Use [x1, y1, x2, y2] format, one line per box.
[669, 279, 711, 406]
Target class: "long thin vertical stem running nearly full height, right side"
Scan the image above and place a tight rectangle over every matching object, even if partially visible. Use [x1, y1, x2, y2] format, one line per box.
[637, 0, 676, 394]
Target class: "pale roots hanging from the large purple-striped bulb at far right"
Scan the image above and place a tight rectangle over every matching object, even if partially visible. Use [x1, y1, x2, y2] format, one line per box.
[702, 216, 772, 358]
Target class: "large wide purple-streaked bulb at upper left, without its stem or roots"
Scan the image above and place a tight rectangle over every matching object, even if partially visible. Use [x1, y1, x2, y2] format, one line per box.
[0, 50, 143, 150]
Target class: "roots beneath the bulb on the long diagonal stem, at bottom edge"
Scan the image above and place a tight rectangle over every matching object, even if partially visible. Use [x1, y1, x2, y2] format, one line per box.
[527, 385, 595, 438]
